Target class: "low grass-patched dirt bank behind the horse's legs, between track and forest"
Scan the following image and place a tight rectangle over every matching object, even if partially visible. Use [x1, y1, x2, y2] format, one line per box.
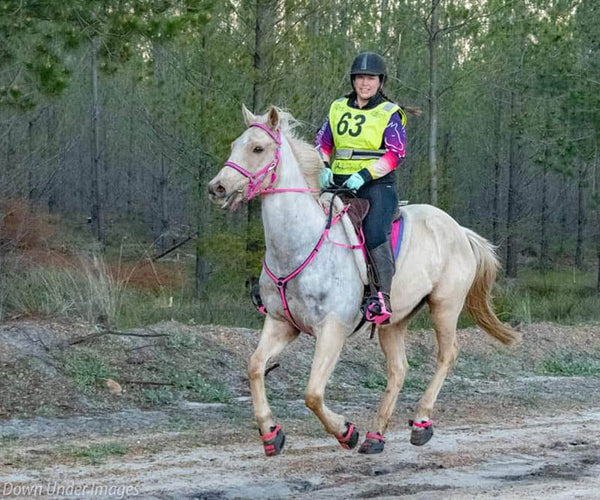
[0, 321, 600, 417]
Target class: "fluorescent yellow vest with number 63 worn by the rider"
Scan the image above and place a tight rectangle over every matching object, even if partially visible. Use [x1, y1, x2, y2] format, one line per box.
[329, 97, 406, 175]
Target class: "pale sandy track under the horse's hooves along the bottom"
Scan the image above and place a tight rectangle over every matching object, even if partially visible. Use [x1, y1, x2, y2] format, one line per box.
[0, 408, 600, 499]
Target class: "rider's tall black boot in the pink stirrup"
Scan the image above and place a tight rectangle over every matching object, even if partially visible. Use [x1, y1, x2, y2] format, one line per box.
[365, 241, 396, 325]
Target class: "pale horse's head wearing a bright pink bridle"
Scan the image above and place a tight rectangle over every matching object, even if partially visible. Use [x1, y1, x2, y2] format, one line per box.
[208, 106, 281, 211]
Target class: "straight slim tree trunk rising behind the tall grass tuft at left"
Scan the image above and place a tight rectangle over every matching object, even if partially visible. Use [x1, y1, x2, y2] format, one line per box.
[90, 39, 104, 243]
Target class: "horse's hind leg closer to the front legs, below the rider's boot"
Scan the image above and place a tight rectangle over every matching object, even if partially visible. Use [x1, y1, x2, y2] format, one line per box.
[359, 320, 408, 454]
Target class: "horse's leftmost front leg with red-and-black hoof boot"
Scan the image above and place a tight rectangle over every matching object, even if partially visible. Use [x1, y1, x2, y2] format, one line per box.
[248, 315, 299, 456]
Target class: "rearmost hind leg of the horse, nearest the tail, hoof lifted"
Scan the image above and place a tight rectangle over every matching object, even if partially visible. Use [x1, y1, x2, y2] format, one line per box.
[410, 297, 463, 446]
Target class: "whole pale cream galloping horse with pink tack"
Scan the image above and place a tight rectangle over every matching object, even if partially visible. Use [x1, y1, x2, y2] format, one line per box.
[208, 107, 520, 455]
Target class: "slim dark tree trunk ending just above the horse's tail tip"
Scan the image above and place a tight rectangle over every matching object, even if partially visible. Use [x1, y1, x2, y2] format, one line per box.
[506, 91, 518, 278]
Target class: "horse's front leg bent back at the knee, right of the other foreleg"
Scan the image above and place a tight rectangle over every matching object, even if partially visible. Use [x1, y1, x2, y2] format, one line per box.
[305, 319, 358, 449]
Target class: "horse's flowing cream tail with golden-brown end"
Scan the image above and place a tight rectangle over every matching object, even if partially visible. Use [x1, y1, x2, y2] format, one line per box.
[463, 228, 521, 344]
